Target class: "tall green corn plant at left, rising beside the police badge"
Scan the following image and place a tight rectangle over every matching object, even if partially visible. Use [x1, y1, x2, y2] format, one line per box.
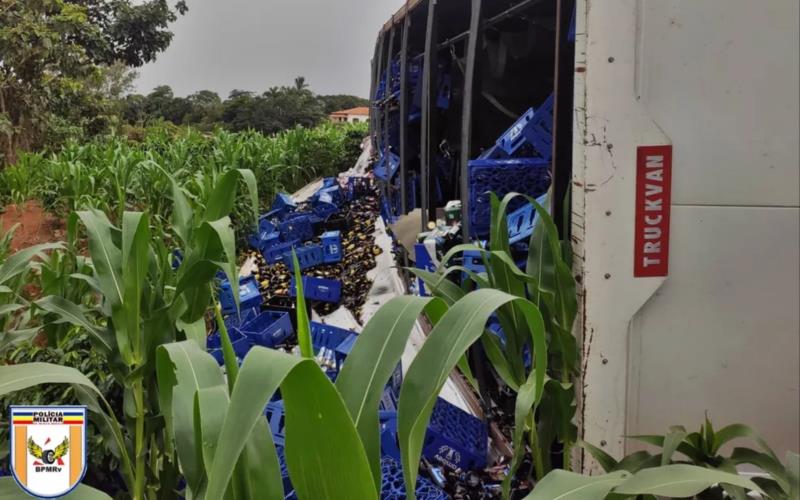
[0, 170, 257, 499]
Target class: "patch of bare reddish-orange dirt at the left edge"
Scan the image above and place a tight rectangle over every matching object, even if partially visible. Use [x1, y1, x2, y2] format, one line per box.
[0, 201, 64, 252]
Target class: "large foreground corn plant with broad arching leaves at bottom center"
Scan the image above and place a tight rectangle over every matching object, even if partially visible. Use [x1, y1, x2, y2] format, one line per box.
[152, 247, 547, 499]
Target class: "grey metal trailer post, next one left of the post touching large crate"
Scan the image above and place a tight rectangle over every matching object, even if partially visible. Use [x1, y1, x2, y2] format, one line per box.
[420, 0, 439, 231]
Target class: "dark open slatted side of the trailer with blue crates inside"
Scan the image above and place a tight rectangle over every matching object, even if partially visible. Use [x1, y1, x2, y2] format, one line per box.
[371, 0, 575, 239]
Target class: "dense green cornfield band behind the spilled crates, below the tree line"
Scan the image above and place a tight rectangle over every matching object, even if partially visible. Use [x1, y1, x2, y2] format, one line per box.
[0, 124, 366, 241]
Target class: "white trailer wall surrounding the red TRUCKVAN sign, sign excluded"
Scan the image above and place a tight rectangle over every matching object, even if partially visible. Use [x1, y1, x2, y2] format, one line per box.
[573, 0, 800, 468]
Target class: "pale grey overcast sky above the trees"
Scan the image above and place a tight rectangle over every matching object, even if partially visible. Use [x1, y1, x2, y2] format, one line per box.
[137, 0, 404, 99]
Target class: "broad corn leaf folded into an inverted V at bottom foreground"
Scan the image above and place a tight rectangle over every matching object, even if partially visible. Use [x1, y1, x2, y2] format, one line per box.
[206, 347, 377, 499]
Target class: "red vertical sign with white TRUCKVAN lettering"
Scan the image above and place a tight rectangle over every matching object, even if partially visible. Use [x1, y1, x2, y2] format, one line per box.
[633, 146, 672, 278]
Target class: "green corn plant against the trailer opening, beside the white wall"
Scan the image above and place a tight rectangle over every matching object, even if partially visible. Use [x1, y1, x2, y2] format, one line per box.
[410, 193, 579, 488]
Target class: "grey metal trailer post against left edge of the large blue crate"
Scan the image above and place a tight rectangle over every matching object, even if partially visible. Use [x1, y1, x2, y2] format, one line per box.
[459, 0, 483, 243]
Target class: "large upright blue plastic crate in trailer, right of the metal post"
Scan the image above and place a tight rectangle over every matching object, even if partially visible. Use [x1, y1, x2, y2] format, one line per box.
[468, 158, 550, 237]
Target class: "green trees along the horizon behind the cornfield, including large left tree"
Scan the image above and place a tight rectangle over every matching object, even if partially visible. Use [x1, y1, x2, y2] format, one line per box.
[0, 0, 366, 167]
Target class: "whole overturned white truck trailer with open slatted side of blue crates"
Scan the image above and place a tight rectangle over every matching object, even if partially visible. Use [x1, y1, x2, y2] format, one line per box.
[371, 0, 800, 469]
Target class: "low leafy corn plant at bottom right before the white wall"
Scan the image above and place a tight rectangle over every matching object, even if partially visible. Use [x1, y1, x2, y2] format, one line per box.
[582, 418, 800, 500]
